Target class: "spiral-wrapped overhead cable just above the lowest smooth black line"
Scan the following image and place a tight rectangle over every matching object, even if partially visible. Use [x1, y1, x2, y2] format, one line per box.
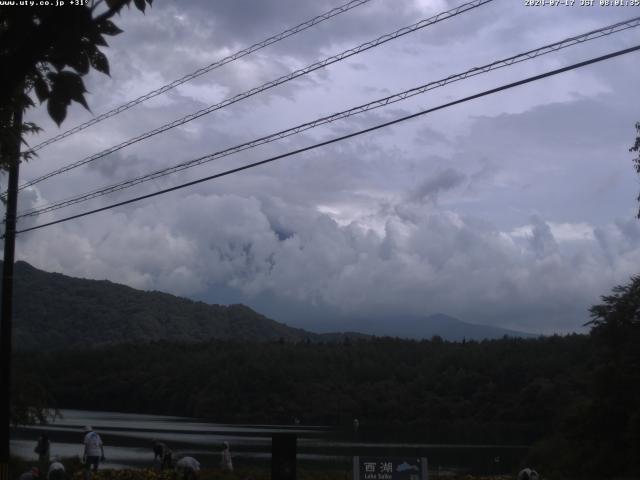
[18, 17, 640, 218]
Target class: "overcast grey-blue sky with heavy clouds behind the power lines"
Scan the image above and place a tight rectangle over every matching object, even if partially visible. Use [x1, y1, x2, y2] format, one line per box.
[5, 0, 640, 333]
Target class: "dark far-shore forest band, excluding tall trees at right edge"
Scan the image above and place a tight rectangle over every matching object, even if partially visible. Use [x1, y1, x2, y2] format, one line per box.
[16, 335, 589, 444]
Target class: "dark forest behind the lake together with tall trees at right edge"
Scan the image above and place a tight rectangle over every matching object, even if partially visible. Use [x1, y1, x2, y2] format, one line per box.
[14, 277, 640, 478]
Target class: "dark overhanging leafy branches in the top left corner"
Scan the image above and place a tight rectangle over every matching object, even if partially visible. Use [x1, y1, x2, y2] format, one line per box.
[0, 0, 153, 169]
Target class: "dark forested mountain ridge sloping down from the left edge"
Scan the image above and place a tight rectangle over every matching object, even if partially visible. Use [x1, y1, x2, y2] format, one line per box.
[6, 262, 321, 350]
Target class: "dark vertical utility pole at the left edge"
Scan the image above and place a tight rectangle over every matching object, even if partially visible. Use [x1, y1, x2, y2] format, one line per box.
[0, 102, 22, 480]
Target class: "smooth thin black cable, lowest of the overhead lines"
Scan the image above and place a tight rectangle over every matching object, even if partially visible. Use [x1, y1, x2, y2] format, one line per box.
[11, 45, 640, 237]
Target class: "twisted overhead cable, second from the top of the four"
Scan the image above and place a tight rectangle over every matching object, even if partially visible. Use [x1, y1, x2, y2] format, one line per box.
[19, 0, 493, 190]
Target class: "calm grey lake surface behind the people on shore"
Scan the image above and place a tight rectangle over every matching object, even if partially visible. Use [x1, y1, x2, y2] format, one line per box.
[11, 410, 528, 473]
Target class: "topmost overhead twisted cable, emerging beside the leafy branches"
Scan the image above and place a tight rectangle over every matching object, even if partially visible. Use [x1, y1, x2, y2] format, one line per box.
[26, 0, 371, 152]
